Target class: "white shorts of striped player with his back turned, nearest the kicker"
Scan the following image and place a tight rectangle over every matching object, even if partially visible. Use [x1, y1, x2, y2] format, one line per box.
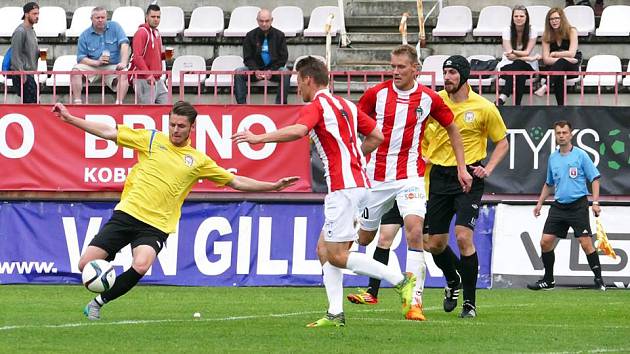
[323, 188, 368, 242]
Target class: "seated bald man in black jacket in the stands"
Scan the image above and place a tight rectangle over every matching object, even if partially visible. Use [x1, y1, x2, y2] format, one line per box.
[234, 9, 291, 104]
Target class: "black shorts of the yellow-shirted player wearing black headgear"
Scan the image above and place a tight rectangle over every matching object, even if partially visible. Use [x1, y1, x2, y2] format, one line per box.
[424, 163, 484, 235]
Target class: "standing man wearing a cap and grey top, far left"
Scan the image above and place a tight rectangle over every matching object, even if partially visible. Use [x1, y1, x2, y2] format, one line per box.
[11, 2, 39, 103]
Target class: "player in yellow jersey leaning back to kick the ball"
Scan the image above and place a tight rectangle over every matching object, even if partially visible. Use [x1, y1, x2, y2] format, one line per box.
[53, 101, 298, 320]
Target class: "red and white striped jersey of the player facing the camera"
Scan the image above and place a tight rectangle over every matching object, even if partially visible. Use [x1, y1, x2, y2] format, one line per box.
[359, 80, 453, 182]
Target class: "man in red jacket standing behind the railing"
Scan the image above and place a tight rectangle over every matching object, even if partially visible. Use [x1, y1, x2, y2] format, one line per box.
[129, 4, 168, 104]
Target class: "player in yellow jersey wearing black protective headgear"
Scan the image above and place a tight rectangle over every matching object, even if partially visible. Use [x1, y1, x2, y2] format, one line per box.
[425, 55, 509, 318]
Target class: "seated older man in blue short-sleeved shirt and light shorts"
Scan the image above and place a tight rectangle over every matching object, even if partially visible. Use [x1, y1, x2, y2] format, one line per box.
[71, 6, 129, 104]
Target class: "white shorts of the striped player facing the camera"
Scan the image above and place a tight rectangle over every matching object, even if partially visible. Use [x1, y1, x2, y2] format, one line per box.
[361, 177, 427, 231]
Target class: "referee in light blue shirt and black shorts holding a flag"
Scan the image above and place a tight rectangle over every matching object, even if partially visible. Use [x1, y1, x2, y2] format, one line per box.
[527, 120, 606, 290]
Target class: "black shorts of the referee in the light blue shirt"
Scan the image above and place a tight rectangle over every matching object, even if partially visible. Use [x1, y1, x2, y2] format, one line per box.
[543, 196, 592, 238]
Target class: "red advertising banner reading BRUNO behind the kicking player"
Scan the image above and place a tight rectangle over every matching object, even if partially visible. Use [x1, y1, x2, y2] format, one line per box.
[0, 105, 311, 192]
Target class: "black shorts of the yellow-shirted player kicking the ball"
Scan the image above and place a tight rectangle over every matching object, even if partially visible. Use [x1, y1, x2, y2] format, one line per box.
[90, 210, 168, 262]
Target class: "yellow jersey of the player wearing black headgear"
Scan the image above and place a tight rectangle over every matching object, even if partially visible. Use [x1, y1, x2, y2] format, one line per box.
[427, 87, 507, 166]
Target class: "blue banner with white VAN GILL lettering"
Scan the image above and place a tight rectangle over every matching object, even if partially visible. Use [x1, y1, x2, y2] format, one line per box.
[0, 202, 494, 287]
